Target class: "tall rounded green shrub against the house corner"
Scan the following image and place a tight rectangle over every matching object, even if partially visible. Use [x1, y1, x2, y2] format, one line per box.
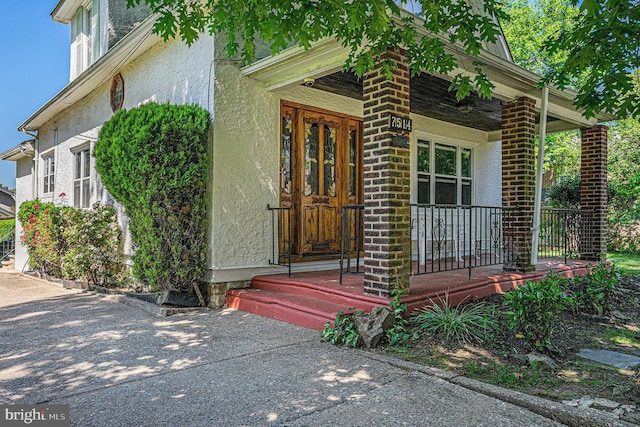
[94, 103, 210, 291]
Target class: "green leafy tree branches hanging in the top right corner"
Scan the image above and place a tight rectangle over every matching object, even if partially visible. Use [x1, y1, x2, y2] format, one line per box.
[545, 0, 640, 118]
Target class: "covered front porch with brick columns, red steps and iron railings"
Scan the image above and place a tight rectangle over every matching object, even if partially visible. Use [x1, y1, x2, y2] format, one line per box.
[226, 28, 607, 328]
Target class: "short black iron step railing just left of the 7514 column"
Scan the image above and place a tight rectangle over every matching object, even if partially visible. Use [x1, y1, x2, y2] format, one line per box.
[340, 205, 364, 283]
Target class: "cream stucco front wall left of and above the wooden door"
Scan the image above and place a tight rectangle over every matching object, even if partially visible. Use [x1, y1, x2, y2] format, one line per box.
[209, 63, 362, 282]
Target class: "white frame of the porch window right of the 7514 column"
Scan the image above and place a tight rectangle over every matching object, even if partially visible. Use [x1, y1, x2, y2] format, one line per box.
[416, 136, 475, 206]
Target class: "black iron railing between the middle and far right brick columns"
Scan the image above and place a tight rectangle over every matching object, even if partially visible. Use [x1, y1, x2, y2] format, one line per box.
[538, 208, 594, 262]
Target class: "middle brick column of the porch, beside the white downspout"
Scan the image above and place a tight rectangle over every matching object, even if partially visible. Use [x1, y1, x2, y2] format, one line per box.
[502, 97, 536, 272]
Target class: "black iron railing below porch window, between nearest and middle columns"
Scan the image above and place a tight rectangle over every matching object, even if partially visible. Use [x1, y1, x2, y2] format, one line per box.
[411, 205, 514, 277]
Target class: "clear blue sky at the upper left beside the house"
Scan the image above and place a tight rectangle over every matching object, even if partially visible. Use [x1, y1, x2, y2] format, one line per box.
[0, 0, 70, 188]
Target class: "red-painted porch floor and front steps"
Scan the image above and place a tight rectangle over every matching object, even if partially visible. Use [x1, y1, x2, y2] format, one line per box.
[226, 258, 589, 330]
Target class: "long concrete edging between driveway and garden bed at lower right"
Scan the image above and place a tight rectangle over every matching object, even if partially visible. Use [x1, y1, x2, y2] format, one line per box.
[350, 349, 636, 427]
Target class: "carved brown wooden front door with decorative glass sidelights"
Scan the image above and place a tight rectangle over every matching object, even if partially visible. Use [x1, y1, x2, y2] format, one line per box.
[280, 104, 362, 255]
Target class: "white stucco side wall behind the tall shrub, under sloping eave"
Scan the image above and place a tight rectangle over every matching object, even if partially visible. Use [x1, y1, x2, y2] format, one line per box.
[16, 36, 213, 265]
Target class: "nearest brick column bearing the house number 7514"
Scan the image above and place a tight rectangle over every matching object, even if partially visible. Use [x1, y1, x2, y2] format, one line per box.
[363, 50, 411, 297]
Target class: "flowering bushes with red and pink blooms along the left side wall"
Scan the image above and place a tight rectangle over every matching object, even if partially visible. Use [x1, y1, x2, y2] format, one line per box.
[18, 200, 122, 286]
